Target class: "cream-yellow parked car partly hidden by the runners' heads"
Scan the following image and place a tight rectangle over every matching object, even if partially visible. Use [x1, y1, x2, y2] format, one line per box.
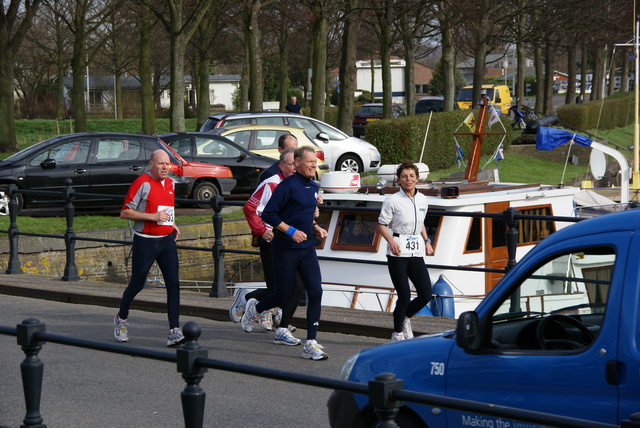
[211, 125, 329, 180]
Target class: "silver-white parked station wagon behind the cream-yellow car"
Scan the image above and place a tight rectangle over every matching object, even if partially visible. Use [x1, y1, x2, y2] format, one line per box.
[200, 111, 380, 173]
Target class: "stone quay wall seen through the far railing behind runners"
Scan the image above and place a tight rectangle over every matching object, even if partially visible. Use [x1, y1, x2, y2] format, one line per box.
[0, 219, 264, 287]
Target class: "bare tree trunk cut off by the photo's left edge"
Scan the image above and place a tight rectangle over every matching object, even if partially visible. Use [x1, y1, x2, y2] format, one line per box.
[0, 0, 40, 152]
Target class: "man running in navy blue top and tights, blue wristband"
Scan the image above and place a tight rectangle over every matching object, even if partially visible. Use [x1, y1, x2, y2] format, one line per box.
[241, 146, 328, 361]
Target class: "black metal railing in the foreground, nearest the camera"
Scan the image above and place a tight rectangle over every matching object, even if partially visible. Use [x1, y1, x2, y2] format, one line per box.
[0, 318, 640, 428]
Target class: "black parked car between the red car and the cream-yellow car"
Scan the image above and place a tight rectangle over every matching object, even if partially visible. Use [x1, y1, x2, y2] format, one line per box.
[158, 132, 273, 194]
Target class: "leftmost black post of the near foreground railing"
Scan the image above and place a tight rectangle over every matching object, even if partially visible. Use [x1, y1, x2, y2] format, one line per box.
[16, 318, 47, 428]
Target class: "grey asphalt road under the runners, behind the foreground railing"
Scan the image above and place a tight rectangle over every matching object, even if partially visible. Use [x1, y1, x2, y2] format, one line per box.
[0, 295, 387, 428]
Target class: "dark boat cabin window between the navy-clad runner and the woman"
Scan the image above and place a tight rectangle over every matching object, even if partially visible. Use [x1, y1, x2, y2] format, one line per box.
[331, 211, 380, 252]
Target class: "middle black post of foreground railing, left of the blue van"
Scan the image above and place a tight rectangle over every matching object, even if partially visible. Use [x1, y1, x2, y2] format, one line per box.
[176, 321, 208, 428]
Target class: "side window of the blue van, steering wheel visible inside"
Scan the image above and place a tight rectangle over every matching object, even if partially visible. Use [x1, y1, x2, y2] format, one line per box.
[487, 247, 616, 352]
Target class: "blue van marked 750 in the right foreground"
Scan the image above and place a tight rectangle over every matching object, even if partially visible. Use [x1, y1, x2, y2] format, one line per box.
[328, 210, 640, 428]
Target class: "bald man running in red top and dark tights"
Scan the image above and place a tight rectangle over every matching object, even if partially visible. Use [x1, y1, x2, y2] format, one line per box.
[114, 149, 185, 346]
